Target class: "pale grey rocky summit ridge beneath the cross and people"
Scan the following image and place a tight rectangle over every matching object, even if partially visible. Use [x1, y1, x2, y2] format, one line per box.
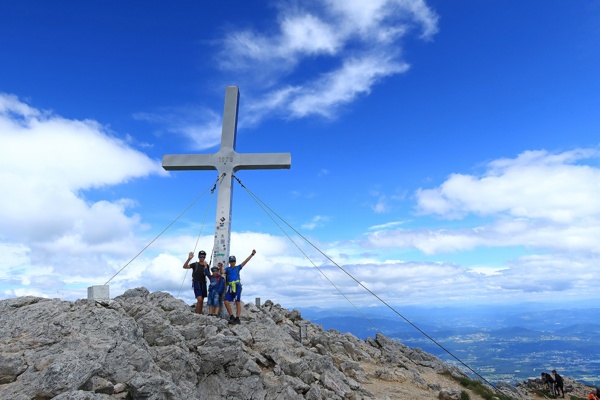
[0, 288, 592, 400]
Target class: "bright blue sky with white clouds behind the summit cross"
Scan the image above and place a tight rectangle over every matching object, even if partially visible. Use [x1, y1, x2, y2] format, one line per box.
[0, 0, 600, 308]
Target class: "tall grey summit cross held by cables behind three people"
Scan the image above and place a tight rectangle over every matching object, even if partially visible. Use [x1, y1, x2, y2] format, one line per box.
[163, 86, 292, 266]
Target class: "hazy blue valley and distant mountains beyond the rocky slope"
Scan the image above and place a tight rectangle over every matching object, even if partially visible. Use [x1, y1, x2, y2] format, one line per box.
[300, 304, 600, 386]
